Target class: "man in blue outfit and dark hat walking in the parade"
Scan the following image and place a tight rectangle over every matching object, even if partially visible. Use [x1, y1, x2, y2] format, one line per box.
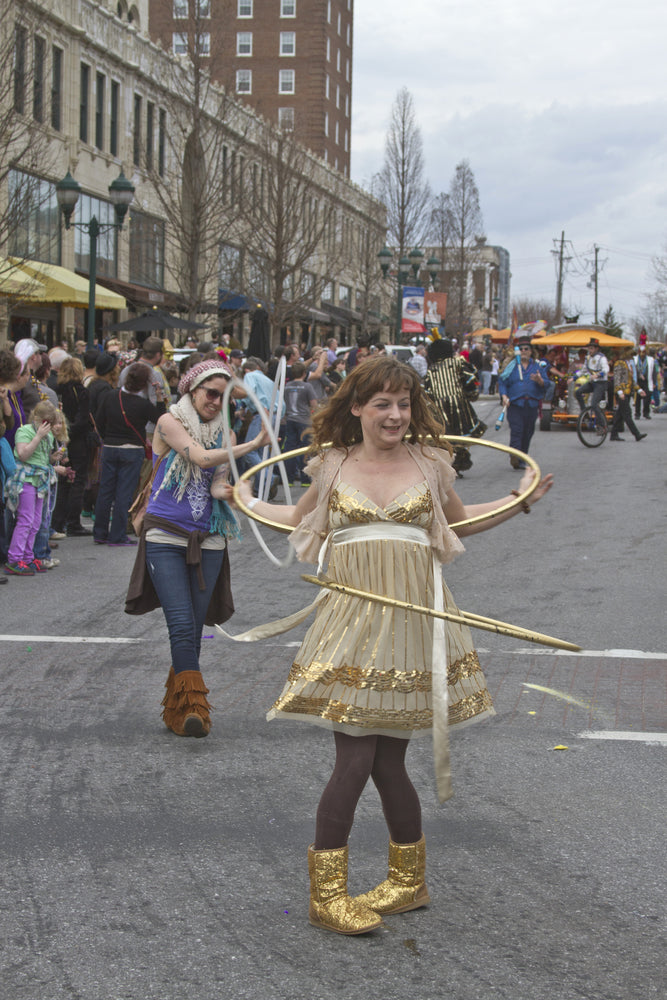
[498, 334, 551, 469]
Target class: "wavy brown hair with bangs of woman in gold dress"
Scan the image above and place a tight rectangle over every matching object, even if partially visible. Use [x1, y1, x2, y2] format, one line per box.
[312, 357, 448, 451]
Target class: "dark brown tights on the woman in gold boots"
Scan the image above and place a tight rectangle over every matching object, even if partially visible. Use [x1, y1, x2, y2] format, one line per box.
[315, 732, 422, 851]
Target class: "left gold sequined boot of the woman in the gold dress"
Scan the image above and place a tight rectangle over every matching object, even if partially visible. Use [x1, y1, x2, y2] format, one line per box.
[308, 845, 382, 934]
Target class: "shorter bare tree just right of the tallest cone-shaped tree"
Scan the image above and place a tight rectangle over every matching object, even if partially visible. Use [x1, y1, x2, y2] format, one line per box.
[438, 160, 485, 335]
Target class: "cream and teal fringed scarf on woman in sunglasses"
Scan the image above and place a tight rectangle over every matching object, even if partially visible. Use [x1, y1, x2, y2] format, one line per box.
[160, 393, 241, 538]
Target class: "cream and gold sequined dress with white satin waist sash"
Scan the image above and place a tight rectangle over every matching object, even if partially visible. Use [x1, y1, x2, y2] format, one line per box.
[267, 481, 494, 739]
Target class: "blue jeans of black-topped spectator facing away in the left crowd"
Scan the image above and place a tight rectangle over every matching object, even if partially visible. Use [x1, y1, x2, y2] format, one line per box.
[93, 445, 144, 544]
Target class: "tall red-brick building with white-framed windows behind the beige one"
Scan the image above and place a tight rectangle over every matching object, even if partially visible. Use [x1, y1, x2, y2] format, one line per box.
[149, 0, 354, 177]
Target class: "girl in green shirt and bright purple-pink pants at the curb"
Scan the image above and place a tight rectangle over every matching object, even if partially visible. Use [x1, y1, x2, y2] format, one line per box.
[5, 401, 66, 576]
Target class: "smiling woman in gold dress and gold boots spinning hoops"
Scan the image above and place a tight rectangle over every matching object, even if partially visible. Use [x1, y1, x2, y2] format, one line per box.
[224, 358, 552, 934]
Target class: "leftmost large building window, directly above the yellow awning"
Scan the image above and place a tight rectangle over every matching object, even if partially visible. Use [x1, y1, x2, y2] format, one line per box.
[7, 170, 59, 264]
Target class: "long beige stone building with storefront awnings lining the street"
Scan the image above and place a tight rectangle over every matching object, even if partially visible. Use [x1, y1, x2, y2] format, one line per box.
[0, 0, 385, 346]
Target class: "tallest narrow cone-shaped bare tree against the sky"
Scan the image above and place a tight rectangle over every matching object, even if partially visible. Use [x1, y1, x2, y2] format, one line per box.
[378, 87, 431, 257]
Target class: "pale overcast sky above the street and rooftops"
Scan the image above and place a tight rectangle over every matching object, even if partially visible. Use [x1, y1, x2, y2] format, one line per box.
[352, 0, 667, 322]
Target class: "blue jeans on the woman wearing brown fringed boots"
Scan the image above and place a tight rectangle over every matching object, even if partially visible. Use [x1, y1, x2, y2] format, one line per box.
[146, 544, 225, 674]
